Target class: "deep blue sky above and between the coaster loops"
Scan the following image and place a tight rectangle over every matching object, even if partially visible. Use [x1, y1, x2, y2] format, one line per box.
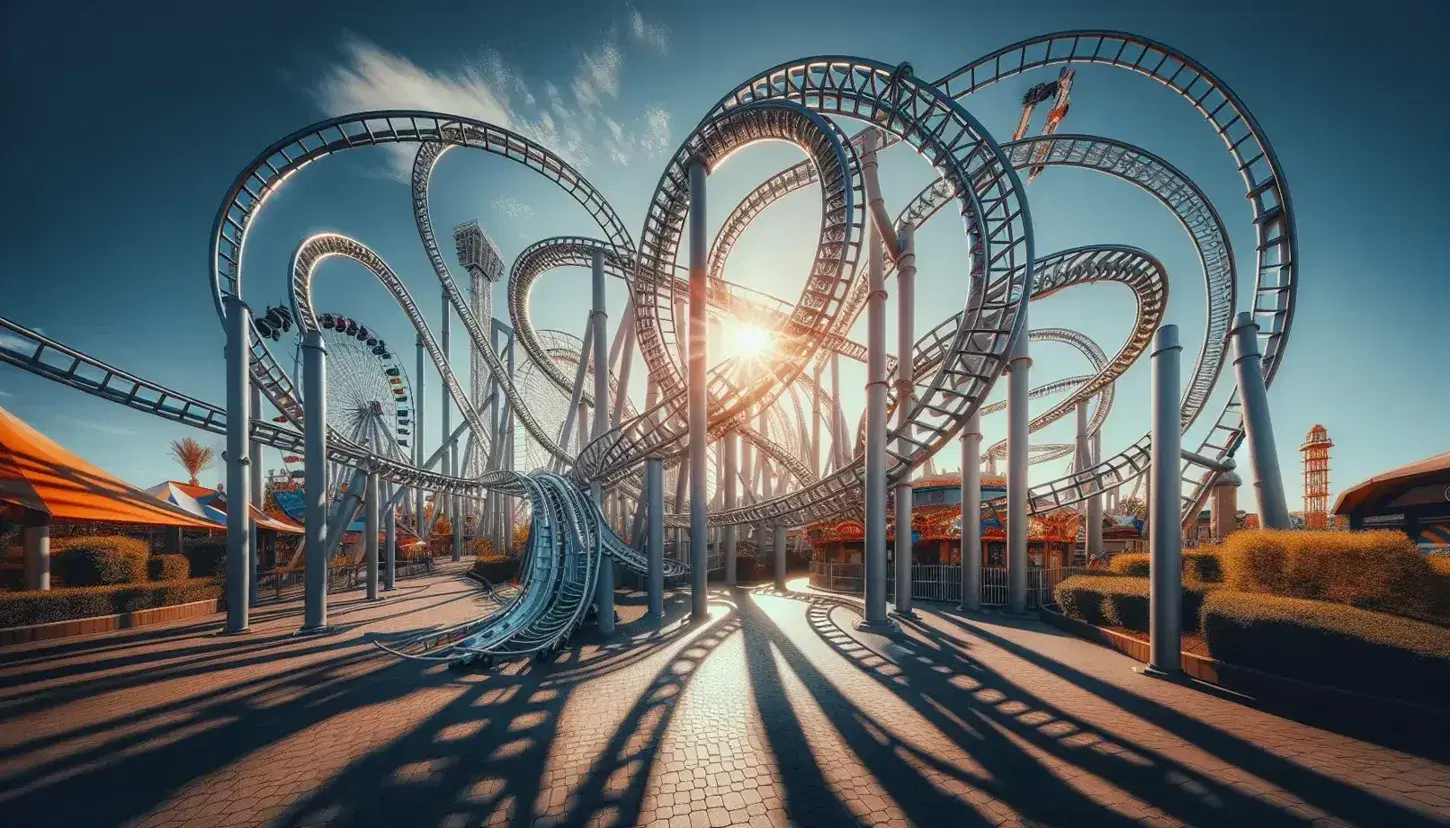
[0, 0, 1450, 508]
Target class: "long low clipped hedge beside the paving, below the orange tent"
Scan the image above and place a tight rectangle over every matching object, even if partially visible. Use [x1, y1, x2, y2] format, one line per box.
[0, 579, 222, 626]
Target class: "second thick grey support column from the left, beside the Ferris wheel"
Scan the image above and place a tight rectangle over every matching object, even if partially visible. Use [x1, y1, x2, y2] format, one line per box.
[302, 331, 330, 632]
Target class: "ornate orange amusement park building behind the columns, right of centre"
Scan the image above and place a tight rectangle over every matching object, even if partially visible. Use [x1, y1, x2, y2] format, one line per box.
[806, 474, 1143, 568]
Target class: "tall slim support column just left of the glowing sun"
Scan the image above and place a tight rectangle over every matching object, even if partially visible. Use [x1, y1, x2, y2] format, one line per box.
[687, 161, 711, 622]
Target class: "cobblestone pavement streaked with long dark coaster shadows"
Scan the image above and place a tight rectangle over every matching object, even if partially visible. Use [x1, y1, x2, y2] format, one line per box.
[0, 570, 1450, 828]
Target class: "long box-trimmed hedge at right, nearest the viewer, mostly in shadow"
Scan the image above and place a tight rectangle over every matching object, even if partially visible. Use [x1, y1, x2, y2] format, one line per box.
[1204, 590, 1450, 706]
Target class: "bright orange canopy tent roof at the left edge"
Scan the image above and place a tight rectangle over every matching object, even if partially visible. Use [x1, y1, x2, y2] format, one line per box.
[0, 407, 216, 529]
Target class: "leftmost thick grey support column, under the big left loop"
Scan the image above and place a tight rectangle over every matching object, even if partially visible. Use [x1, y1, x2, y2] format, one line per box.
[226, 296, 252, 634]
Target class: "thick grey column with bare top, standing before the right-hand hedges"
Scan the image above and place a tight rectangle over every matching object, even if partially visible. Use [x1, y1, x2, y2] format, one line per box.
[1148, 325, 1183, 674]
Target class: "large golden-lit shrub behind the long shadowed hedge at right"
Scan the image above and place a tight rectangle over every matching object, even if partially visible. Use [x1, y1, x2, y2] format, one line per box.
[1224, 529, 1438, 618]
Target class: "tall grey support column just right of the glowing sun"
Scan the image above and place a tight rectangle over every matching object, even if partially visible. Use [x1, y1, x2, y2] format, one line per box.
[861, 129, 893, 631]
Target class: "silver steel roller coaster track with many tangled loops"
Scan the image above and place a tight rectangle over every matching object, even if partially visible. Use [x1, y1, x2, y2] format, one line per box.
[0, 30, 1298, 661]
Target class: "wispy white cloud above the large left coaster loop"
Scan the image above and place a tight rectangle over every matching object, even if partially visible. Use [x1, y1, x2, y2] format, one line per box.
[313, 6, 670, 180]
